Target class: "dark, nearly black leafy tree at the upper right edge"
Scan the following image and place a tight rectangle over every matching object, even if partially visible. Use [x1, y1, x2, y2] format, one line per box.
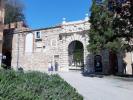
[109, 0, 133, 51]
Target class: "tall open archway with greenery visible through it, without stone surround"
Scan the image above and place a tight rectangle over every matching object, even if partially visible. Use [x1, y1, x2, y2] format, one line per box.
[68, 40, 84, 70]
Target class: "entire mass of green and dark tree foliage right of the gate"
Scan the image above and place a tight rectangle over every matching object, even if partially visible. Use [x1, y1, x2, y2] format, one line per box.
[88, 0, 133, 53]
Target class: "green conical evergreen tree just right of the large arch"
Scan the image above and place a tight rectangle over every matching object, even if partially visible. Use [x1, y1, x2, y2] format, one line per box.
[88, 0, 122, 53]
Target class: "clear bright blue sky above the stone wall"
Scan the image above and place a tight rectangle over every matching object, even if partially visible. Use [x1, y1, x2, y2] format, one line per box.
[21, 0, 92, 29]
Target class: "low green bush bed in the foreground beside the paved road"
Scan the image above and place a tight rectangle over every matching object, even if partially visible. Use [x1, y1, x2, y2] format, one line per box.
[0, 70, 83, 100]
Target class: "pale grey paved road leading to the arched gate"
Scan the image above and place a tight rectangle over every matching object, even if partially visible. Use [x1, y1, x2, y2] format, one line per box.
[59, 72, 133, 100]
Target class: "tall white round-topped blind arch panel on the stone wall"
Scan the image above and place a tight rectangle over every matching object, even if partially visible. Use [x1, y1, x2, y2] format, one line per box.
[25, 33, 33, 53]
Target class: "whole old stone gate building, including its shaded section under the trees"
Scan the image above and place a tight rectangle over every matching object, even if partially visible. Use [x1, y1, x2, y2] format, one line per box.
[3, 16, 132, 74]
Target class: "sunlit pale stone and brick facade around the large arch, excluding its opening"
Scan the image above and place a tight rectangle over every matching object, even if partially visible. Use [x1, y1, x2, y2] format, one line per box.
[12, 20, 90, 71]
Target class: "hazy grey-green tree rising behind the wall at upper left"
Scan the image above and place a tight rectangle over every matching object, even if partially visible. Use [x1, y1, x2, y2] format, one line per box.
[5, 0, 25, 24]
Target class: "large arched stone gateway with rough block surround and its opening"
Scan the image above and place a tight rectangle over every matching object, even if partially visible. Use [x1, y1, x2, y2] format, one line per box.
[60, 28, 88, 71]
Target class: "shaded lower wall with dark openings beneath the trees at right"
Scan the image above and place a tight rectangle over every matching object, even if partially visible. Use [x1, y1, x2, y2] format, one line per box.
[83, 52, 133, 76]
